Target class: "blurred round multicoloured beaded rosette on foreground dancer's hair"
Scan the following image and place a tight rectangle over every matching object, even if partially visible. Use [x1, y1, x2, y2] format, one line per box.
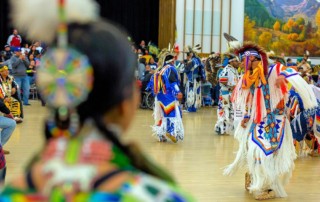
[37, 48, 93, 107]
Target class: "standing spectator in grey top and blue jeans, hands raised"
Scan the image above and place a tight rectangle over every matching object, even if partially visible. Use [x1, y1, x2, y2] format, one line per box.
[11, 48, 30, 105]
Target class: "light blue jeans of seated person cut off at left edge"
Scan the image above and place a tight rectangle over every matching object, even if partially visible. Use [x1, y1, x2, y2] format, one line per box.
[0, 116, 16, 146]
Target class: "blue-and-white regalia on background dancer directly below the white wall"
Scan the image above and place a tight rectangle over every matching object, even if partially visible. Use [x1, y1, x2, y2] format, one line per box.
[185, 56, 205, 112]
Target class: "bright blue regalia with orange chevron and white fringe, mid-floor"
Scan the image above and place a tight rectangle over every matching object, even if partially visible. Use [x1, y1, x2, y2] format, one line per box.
[148, 64, 184, 142]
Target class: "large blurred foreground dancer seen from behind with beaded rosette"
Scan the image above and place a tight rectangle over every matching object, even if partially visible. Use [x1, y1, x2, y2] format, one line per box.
[0, 0, 192, 201]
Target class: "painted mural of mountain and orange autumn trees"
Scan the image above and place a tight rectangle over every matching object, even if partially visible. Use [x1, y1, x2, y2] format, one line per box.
[244, 0, 320, 57]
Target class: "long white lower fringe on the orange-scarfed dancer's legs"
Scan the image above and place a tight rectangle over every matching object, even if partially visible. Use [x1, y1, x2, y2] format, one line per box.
[247, 116, 297, 197]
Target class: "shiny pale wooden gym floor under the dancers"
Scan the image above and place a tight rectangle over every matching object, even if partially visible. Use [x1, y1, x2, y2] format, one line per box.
[5, 101, 320, 202]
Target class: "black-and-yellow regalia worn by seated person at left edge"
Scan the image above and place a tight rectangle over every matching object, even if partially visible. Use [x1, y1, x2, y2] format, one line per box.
[0, 76, 22, 122]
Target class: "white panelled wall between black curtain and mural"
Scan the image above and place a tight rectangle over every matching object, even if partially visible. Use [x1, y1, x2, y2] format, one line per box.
[176, 0, 244, 56]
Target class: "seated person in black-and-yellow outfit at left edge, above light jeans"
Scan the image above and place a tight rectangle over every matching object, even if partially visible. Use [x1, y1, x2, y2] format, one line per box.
[0, 66, 23, 123]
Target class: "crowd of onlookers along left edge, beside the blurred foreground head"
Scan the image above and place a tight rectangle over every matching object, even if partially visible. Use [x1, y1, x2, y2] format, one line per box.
[0, 29, 46, 154]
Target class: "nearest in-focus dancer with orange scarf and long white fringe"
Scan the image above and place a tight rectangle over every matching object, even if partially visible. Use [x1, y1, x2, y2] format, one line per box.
[224, 43, 317, 200]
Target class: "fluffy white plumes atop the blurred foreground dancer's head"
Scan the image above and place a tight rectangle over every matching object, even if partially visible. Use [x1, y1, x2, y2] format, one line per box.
[11, 0, 99, 42]
